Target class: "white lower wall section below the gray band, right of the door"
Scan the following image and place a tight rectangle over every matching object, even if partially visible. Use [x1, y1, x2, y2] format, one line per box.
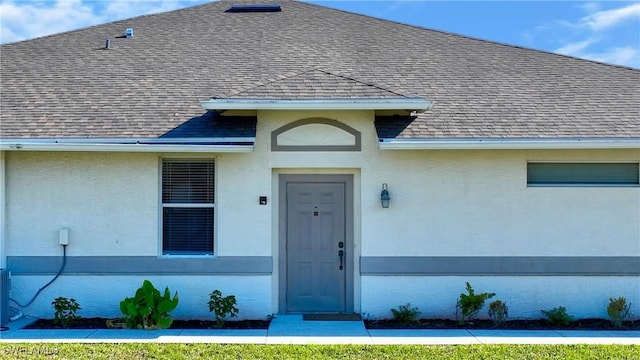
[362, 276, 640, 319]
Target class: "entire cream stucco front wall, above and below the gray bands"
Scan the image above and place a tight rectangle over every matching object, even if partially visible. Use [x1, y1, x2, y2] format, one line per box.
[5, 111, 640, 318]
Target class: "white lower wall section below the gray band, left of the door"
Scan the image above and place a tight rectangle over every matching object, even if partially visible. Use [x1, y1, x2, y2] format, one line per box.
[11, 275, 272, 320]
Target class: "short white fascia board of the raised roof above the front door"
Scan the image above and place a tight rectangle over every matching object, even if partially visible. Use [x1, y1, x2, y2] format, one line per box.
[200, 98, 434, 112]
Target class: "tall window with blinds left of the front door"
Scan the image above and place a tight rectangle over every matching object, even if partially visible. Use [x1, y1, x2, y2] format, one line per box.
[162, 159, 215, 255]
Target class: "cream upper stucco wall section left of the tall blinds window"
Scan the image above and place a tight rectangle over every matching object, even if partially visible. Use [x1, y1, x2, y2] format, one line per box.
[6, 152, 159, 256]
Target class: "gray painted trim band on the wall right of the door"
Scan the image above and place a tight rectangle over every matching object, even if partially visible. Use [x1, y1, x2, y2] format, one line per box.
[360, 256, 640, 276]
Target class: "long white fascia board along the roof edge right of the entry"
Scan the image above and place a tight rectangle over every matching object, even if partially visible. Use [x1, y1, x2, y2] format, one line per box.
[378, 138, 640, 150]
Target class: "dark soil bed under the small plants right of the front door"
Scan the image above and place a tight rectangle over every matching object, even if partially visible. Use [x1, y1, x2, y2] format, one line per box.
[364, 319, 640, 331]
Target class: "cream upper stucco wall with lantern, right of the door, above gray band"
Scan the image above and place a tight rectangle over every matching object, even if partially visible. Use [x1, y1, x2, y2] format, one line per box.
[362, 150, 640, 256]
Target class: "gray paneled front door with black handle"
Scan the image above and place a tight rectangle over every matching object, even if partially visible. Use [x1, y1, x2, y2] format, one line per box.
[286, 182, 348, 313]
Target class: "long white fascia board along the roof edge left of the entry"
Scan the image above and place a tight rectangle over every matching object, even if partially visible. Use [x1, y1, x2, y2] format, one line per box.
[0, 138, 255, 153]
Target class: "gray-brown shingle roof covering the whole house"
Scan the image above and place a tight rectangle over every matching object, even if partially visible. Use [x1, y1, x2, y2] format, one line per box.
[0, 0, 640, 138]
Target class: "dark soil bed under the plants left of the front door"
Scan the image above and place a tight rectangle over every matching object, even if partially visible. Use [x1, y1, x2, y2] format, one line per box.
[25, 317, 271, 329]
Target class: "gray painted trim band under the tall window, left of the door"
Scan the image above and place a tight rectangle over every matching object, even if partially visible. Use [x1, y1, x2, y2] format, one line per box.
[7, 256, 273, 275]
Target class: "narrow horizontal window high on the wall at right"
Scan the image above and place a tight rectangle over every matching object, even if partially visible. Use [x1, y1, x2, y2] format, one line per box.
[527, 163, 640, 186]
